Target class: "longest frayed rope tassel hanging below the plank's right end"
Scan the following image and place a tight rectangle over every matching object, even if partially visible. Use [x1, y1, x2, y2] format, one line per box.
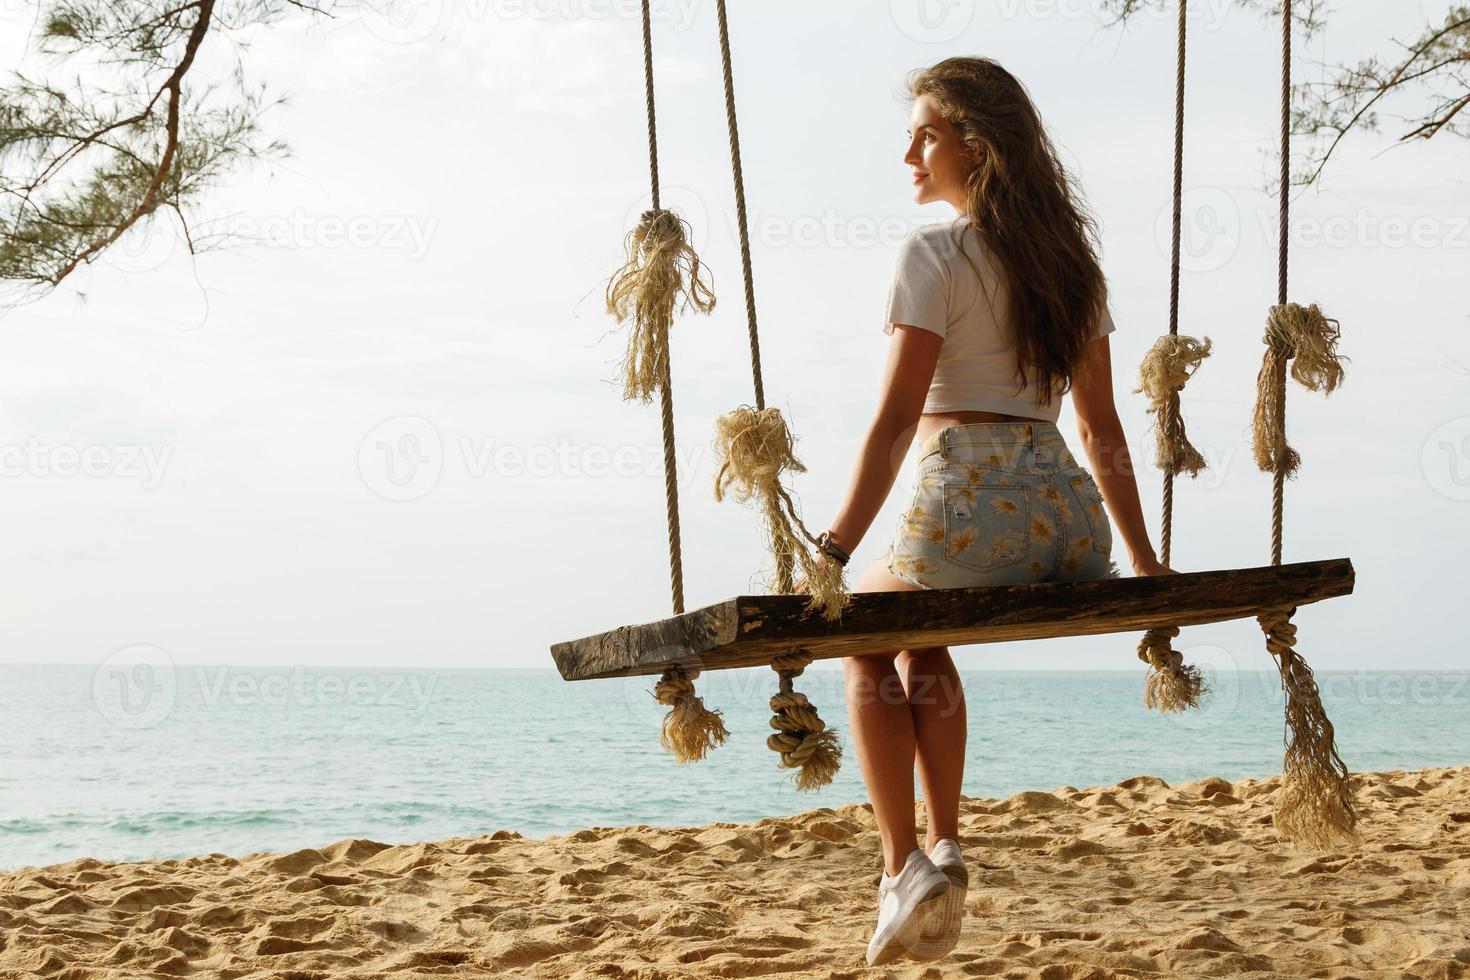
[1255, 607, 1358, 851]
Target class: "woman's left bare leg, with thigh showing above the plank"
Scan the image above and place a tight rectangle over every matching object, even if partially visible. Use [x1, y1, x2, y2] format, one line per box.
[842, 557, 919, 874]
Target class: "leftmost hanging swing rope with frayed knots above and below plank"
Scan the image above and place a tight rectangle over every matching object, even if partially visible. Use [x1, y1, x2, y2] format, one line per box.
[606, 0, 729, 763]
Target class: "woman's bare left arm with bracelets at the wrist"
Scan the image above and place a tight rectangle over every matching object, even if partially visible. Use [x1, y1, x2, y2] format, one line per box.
[829, 323, 944, 554]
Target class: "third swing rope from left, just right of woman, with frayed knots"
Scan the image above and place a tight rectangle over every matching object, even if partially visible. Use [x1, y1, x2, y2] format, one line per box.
[1133, 0, 1210, 714]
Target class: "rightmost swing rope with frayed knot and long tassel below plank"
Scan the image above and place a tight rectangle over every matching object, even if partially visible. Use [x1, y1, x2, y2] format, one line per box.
[1252, 0, 1358, 849]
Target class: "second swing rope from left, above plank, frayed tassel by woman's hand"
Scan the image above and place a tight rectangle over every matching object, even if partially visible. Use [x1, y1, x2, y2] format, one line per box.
[714, 0, 851, 621]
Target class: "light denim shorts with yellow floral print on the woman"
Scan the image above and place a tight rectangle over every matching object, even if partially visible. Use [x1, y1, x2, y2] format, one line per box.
[883, 420, 1119, 589]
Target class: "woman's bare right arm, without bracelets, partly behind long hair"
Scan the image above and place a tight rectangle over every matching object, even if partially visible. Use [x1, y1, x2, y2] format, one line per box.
[1072, 335, 1163, 574]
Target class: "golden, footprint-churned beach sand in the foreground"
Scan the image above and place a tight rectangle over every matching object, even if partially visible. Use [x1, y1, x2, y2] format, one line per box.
[0, 767, 1470, 980]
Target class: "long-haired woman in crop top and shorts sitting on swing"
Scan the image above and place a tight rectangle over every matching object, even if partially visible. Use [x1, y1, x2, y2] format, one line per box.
[805, 57, 1173, 965]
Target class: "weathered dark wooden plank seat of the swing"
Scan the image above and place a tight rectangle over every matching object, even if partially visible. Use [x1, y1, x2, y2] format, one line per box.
[551, 558, 1354, 680]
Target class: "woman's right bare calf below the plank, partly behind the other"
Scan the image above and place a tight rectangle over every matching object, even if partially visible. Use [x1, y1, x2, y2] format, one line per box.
[897, 646, 969, 851]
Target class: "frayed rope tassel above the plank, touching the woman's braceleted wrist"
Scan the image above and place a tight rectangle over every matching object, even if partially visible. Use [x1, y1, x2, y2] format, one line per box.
[714, 406, 853, 621]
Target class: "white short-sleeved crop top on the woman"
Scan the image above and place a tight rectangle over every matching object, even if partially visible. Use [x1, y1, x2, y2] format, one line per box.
[883, 217, 1117, 422]
